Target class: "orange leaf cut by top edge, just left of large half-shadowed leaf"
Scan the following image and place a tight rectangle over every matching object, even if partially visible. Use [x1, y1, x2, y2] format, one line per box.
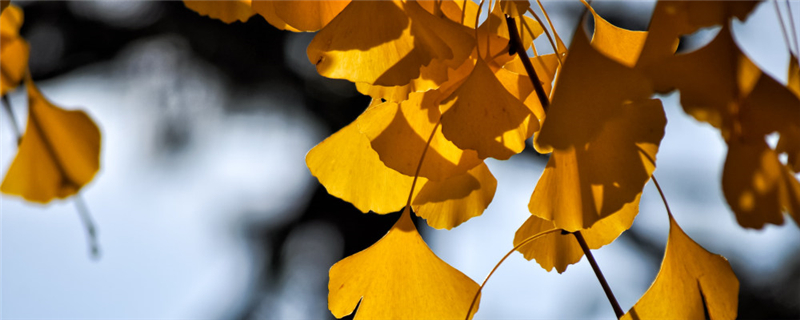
[273, 0, 350, 31]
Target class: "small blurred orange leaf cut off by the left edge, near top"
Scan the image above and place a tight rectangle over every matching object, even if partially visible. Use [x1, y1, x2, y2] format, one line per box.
[0, 6, 29, 96]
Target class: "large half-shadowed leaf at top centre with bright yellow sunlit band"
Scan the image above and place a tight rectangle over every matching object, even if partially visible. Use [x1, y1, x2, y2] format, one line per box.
[307, 1, 474, 86]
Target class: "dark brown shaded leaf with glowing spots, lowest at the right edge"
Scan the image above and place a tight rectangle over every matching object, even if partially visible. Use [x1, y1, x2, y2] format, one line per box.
[722, 137, 800, 229]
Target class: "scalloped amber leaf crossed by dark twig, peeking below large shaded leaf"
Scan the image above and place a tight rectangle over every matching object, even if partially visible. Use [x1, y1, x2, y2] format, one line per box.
[514, 195, 641, 273]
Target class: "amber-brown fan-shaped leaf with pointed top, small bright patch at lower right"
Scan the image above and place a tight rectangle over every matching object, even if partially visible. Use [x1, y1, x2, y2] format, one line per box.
[440, 59, 539, 160]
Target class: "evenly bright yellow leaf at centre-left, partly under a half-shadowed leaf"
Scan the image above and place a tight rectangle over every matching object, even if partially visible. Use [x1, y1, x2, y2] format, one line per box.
[306, 113, 419, 214]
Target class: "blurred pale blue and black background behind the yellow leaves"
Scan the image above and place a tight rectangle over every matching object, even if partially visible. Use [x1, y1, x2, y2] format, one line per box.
[0, 0, 800, 319]
